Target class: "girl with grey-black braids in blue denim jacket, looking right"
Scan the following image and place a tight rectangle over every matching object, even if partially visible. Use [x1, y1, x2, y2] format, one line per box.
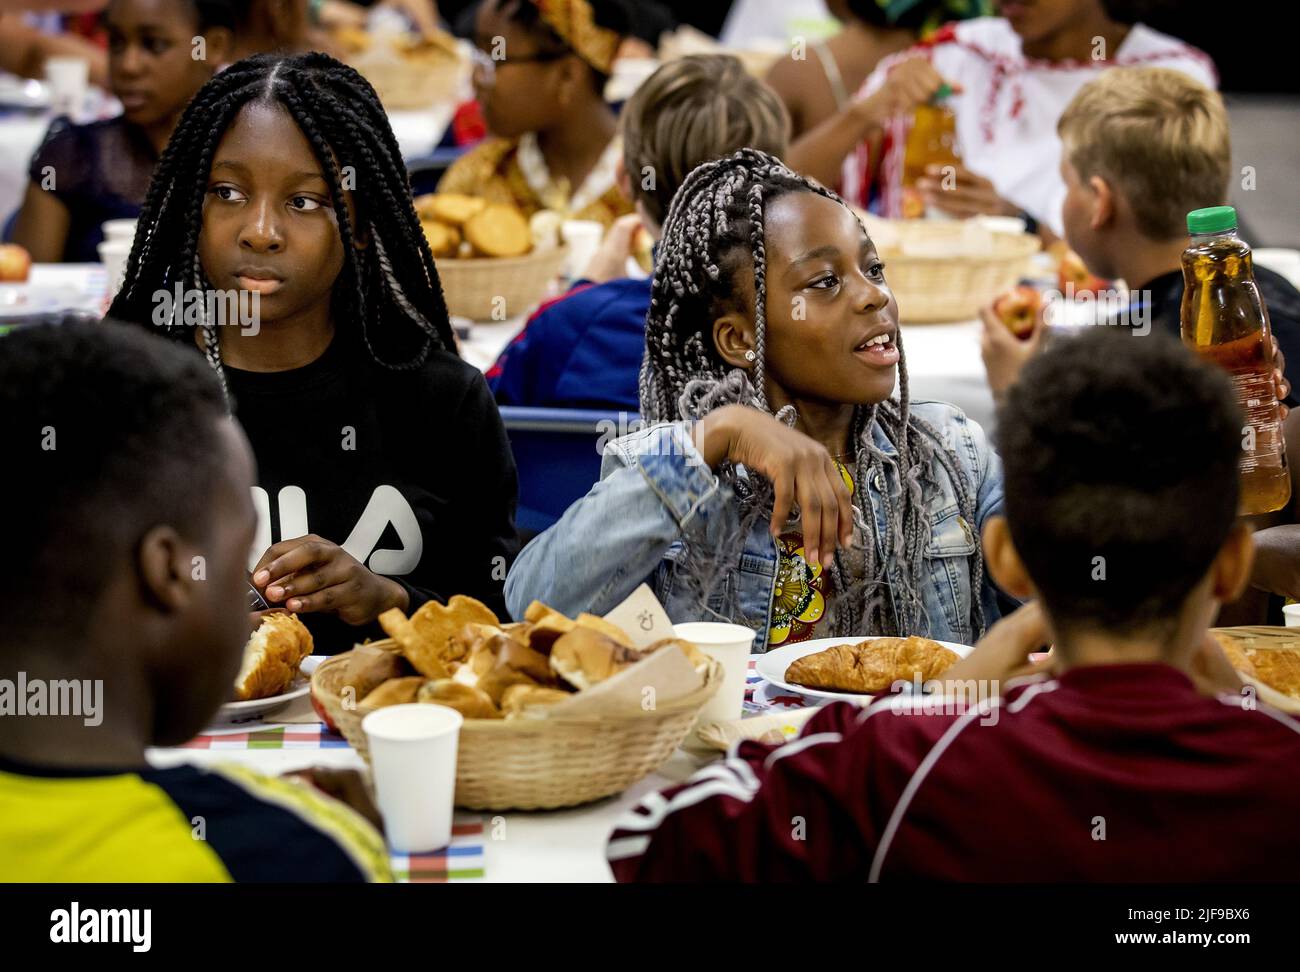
[506, 149, 1002, 651]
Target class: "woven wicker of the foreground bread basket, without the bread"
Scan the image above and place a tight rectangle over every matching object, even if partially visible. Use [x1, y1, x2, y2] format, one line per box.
[312, 641, 723, 810]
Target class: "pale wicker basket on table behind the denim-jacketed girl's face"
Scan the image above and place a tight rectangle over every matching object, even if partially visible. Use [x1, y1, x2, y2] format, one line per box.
[859, 213, 1043, 324]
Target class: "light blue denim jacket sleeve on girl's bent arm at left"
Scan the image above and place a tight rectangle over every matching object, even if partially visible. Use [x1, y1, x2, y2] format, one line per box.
[506, 422, 735, 617]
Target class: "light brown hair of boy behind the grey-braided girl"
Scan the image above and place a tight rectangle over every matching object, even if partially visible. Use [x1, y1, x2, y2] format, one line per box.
[623, 55, 790, 226]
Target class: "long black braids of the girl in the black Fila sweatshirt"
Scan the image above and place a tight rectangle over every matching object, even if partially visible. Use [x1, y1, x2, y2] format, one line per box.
[109, 53, 455, 387]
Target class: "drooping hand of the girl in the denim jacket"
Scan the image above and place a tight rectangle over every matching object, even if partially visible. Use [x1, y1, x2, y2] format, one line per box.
[696, 405, 853, 568]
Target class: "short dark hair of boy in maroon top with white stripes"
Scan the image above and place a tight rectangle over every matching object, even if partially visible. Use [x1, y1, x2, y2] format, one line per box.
[997, 327, 1243, 633]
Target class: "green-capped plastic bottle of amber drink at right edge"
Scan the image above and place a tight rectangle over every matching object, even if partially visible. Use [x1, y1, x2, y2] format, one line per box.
[1182, 205, 1291, 516]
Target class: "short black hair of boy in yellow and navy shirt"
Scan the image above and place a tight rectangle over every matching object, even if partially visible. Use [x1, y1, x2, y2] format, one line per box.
[0, 322, 225, 651]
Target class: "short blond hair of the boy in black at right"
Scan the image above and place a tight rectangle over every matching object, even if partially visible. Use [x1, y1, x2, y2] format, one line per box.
[1057, 68, 1232, 240]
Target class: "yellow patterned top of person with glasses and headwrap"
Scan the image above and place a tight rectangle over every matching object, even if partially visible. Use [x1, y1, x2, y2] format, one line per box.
[438, 133, 632, 226]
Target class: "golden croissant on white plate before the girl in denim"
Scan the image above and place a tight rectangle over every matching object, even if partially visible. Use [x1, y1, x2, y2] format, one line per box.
[785, 637, 958, 694]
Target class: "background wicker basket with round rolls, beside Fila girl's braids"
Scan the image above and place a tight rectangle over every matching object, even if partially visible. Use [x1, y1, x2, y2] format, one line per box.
[415, 192, 567, 321]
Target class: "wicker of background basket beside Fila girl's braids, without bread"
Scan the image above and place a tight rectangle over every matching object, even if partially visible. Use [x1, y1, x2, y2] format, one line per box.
[434, 247, 568, 321]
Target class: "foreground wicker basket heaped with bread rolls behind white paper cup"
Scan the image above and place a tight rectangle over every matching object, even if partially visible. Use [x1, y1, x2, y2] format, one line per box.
[312, 595, 723, 810]
